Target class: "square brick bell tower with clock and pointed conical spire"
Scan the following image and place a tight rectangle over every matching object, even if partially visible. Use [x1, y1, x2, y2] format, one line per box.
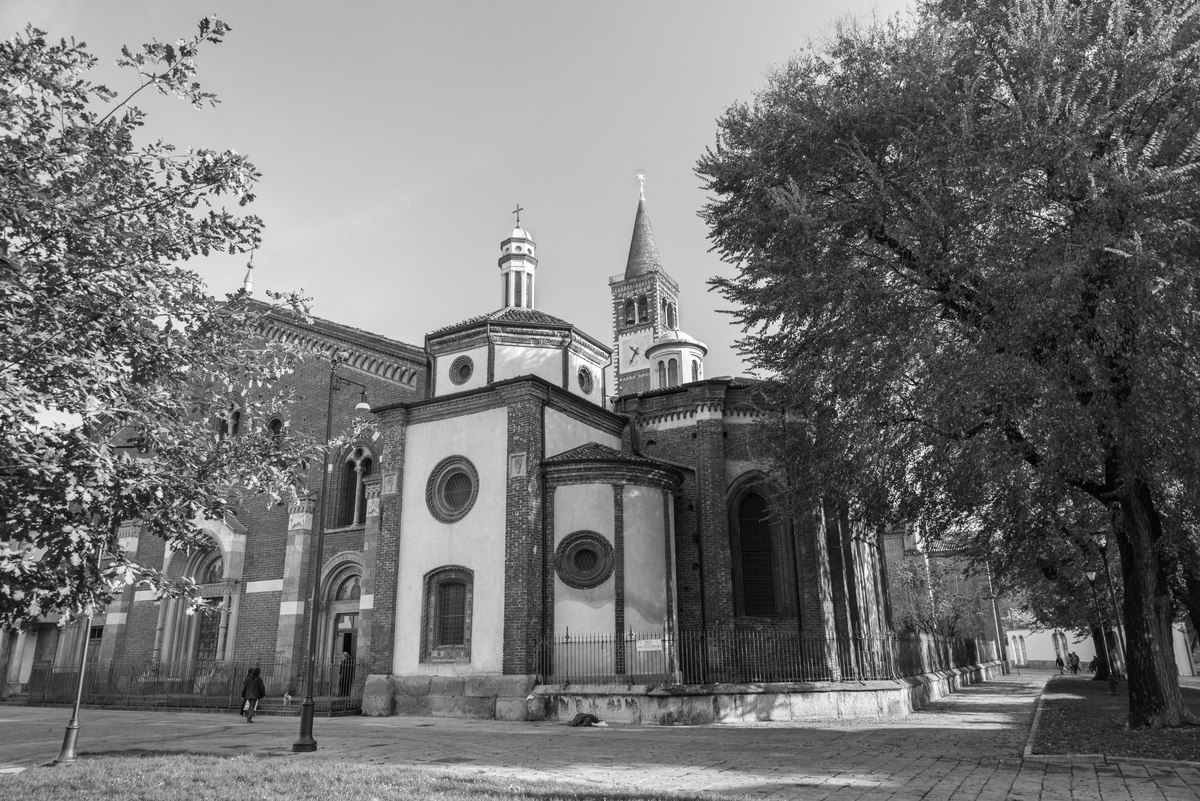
[608, 173, 679, 396]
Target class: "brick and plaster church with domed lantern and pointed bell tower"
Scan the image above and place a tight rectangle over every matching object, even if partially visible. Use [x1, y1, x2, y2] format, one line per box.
[0, 185, 890, 719]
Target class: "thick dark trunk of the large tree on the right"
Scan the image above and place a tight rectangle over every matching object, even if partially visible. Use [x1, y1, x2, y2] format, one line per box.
[1114, 477, 1195, 729]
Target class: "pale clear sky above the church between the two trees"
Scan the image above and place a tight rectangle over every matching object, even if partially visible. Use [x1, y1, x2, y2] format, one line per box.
[0, 0, 910, 377]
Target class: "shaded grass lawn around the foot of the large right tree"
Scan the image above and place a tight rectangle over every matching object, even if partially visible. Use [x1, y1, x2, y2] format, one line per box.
[1033, 676, 1200, 761]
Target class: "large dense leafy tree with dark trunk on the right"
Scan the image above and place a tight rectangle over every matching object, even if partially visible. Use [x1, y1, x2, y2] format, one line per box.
[697, 0, 1200, 727]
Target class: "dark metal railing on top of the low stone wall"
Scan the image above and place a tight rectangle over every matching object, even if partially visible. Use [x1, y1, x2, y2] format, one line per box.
[540, 630, 997, 685]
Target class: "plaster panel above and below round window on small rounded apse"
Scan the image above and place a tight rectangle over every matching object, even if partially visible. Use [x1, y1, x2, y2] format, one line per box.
[554, 484, 614, 637]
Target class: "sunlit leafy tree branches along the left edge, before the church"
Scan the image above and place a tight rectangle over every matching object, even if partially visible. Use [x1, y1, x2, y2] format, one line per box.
[0, 19, 313, 628]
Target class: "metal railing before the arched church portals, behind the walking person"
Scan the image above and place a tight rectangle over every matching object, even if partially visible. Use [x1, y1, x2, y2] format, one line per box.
[26, 658, 367, 713]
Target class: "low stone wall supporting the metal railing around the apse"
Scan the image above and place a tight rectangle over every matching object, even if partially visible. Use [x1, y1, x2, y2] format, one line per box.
[529, 662, 1003, 725]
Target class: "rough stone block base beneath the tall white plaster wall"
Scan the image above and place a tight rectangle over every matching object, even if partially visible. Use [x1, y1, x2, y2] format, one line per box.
[362, 674, 538, 721]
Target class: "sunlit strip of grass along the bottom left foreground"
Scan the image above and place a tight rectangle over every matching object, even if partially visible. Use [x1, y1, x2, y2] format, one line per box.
[0, 754, 712, 801]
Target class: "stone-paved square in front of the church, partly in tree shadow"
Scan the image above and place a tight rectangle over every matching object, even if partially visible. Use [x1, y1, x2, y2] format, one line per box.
[0, 671, 1200, 801]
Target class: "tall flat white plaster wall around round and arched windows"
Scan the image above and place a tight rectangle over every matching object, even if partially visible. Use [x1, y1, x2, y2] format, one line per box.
[392, 408, 508, 675]
